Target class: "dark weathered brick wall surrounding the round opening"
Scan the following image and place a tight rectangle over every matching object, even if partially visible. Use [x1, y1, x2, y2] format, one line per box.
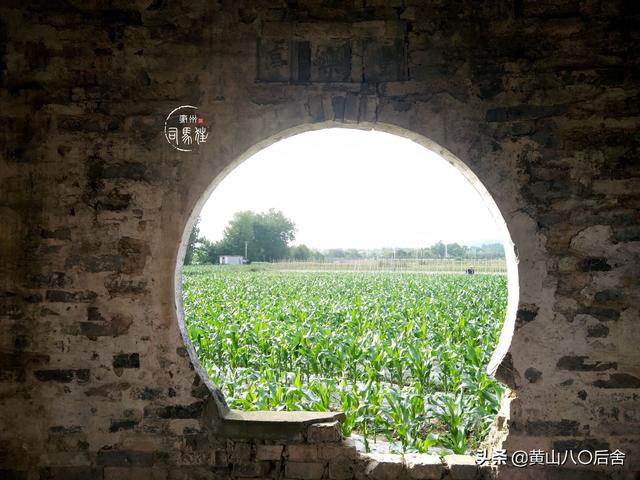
[0, 0, 640, 480]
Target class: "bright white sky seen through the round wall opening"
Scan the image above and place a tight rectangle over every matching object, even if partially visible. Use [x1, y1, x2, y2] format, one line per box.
[200, 128, 502, 249]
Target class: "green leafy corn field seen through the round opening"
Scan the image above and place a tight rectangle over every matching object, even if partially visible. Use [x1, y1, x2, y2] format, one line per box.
[183, 266, 507, 453]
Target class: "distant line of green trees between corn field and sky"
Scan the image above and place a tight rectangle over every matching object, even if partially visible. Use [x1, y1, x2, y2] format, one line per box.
[184, 209, 504, 265]
